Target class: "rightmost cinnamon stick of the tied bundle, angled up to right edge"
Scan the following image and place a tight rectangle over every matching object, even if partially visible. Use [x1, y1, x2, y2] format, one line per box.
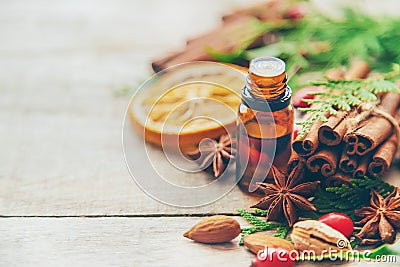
[368, 134, 398, 176]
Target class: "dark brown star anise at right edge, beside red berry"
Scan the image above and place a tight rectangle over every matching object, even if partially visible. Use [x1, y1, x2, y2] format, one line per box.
[355, 187, 400, 244]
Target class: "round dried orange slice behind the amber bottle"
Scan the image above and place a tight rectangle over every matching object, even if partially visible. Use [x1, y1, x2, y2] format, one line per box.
[128, 62, 247, 151]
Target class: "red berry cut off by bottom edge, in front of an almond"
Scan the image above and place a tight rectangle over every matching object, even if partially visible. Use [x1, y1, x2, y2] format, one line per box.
[251, 247, 296, 267]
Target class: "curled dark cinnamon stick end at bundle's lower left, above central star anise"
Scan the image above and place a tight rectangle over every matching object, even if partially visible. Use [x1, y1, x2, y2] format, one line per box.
[307, 148, 338, 177]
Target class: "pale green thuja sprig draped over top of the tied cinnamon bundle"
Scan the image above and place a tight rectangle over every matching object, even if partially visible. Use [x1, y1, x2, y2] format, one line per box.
[297, 64, 400, 139]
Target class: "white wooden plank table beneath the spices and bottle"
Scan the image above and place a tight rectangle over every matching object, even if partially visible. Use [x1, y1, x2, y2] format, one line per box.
[0, 0, 398, 266]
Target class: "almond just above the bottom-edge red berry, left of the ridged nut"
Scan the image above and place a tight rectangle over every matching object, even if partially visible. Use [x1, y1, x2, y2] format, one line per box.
[243, 233, 295, 254]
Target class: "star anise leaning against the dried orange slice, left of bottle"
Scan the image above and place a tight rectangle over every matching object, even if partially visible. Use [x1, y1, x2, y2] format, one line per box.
[188, 134, 236, 178]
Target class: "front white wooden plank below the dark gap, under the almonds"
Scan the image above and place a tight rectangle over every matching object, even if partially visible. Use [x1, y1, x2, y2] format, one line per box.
[0, 217, 398, 267]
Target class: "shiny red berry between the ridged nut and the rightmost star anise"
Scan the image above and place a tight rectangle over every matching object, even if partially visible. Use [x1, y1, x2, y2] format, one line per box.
[318, 212, 354, 238]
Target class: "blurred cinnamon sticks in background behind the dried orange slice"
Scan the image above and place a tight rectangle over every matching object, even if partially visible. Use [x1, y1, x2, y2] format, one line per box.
[152, 0, 288, 72]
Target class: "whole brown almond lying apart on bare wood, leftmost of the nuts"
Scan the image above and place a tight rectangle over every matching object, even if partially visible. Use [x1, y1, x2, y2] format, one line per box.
[183, 215, 241, 244]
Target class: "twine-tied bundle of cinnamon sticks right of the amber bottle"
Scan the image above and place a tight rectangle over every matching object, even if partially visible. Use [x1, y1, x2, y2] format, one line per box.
[288, 62, 400, 186]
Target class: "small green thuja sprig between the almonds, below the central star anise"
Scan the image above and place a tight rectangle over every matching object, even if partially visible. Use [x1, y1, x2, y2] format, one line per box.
[237, 209, 290, 245]
